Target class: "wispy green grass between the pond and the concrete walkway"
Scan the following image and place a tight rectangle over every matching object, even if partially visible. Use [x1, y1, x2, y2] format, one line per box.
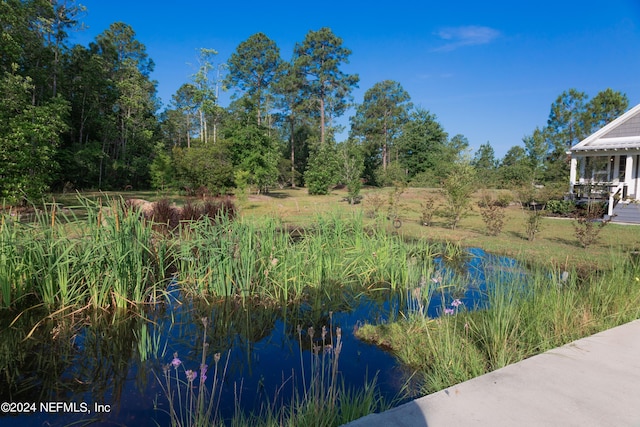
[358, 253, 640, 393]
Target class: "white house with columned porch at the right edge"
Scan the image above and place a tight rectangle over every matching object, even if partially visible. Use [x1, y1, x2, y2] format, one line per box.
[567, 104, 640, 215]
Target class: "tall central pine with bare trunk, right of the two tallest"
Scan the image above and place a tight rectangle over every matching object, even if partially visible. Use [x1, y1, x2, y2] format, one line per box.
[294, 27, 359, 144]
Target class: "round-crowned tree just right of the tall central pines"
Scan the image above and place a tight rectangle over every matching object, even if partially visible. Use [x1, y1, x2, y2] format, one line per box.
[351, 80, 412, 176]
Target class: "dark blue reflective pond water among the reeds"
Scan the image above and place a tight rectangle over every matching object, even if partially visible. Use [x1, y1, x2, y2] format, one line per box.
[0, 249, 524, 426]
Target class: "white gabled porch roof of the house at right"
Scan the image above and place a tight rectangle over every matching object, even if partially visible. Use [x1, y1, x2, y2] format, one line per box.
[569, 104, 640, 154]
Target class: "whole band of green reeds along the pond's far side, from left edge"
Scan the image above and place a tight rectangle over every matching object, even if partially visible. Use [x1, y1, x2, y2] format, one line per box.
[0, 194, 444, 318]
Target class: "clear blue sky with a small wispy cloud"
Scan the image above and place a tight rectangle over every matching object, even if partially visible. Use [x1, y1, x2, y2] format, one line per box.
[72, 0, 640, 157]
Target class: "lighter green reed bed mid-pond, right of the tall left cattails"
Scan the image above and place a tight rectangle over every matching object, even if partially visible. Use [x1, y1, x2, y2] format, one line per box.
[174, 214, 440, 305]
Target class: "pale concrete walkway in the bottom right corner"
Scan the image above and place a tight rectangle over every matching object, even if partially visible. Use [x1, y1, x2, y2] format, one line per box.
[347, 320, 640, 427]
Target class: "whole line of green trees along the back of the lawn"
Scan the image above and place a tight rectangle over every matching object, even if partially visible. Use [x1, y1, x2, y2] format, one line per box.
[0, 0, 628, 203]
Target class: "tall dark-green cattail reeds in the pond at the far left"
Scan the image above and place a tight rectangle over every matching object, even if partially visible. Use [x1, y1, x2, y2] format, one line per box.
[0, 199, 163, 312]
